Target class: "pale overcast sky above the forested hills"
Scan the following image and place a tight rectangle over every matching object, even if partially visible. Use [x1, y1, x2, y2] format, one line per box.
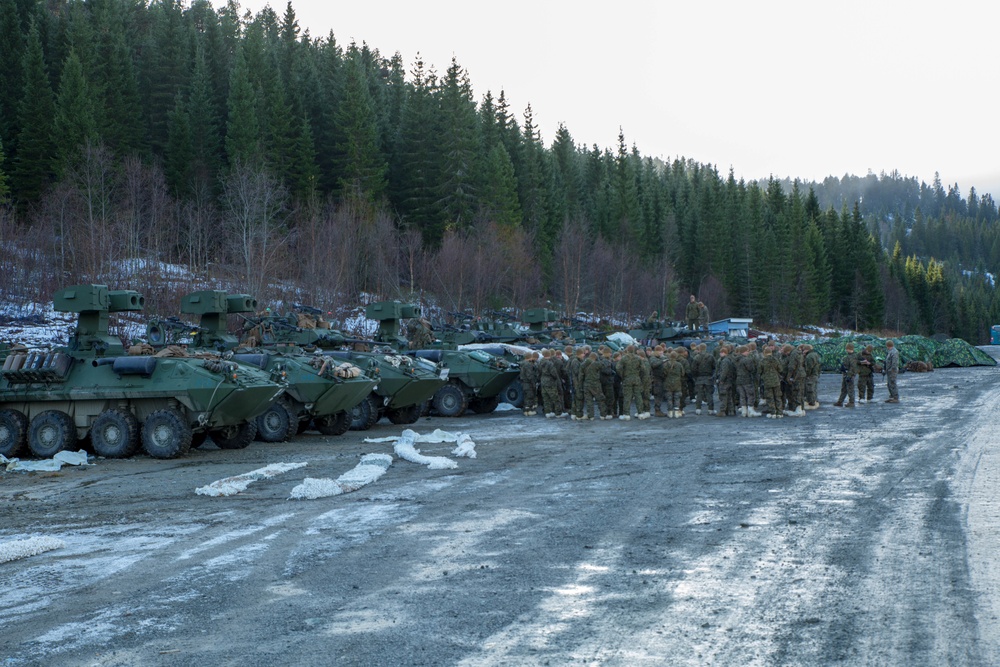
[223, 0, 1000, 199]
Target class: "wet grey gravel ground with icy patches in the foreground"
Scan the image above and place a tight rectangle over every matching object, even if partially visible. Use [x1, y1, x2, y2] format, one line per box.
[0, 368, 1000, 667]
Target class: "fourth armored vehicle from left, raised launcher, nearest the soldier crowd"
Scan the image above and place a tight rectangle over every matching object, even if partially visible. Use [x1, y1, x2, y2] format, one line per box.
[365, 301, 520, 417]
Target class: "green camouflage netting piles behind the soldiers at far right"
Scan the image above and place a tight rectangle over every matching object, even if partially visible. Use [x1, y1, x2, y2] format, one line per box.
[800, 334, 997, 373]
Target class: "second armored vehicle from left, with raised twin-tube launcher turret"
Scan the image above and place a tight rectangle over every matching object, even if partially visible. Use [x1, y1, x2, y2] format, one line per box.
[147, 290, 378, 442]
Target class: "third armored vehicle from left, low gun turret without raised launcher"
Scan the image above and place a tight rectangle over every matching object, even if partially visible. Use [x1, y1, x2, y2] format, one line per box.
[247, 306, 448, 430]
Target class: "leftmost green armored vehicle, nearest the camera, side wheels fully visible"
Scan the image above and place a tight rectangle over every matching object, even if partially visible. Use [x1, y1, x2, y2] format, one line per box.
[0, 285, 284, 458]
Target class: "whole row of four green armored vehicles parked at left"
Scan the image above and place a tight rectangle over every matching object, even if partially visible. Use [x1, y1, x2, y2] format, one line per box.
[0, 285, 518, 458]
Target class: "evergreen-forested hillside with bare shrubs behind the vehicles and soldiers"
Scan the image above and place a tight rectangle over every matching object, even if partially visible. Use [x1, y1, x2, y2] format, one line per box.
[0, 0, 1000, 343]
